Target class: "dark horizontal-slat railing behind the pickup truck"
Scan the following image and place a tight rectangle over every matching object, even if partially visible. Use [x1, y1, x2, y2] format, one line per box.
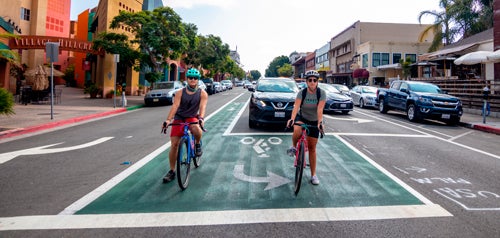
[412, 78, 500, 112]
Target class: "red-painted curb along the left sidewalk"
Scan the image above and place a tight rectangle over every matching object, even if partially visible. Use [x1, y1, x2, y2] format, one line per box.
[0, 105, 143, 140]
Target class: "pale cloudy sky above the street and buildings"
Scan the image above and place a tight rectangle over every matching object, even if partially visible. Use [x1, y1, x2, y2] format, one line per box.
[71, 0, 440, 75]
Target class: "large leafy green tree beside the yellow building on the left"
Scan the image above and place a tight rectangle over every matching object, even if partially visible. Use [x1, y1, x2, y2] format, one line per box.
[110, 7, 196, 80]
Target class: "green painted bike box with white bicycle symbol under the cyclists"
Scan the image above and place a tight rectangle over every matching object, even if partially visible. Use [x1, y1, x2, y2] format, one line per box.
[75, 94, 424, 214]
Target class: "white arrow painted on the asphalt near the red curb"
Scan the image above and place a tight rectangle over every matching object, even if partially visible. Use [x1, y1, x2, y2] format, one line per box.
[0, 137, 113, 164]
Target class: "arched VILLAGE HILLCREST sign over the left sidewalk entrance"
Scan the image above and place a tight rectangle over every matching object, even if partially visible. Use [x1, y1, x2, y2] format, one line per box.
[9, 35, 104, 54]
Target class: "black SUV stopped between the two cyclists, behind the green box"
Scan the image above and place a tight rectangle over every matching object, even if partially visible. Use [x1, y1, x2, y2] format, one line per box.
[248, 78, 299, 128]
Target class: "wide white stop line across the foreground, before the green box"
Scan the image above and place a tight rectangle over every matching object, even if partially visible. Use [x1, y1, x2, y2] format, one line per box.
[0, 204, 452, 231]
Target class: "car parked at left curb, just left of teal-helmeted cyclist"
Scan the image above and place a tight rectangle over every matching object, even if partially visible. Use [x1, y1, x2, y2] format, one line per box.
[144, 81, 184, 106]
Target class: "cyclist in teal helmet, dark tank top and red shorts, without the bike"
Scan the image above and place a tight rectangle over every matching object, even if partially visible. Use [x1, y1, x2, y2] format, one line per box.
[163, 68, 208, 182]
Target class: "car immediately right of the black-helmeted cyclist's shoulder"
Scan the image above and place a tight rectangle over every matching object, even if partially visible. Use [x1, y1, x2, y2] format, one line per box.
[318, 83, 354, 114]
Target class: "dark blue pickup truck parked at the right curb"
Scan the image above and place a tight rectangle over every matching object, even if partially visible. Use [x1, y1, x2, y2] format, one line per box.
[376, 80, 463, 125]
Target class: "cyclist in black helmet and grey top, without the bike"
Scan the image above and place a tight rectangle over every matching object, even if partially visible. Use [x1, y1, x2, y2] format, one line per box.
[287, 70, 326, 185]
